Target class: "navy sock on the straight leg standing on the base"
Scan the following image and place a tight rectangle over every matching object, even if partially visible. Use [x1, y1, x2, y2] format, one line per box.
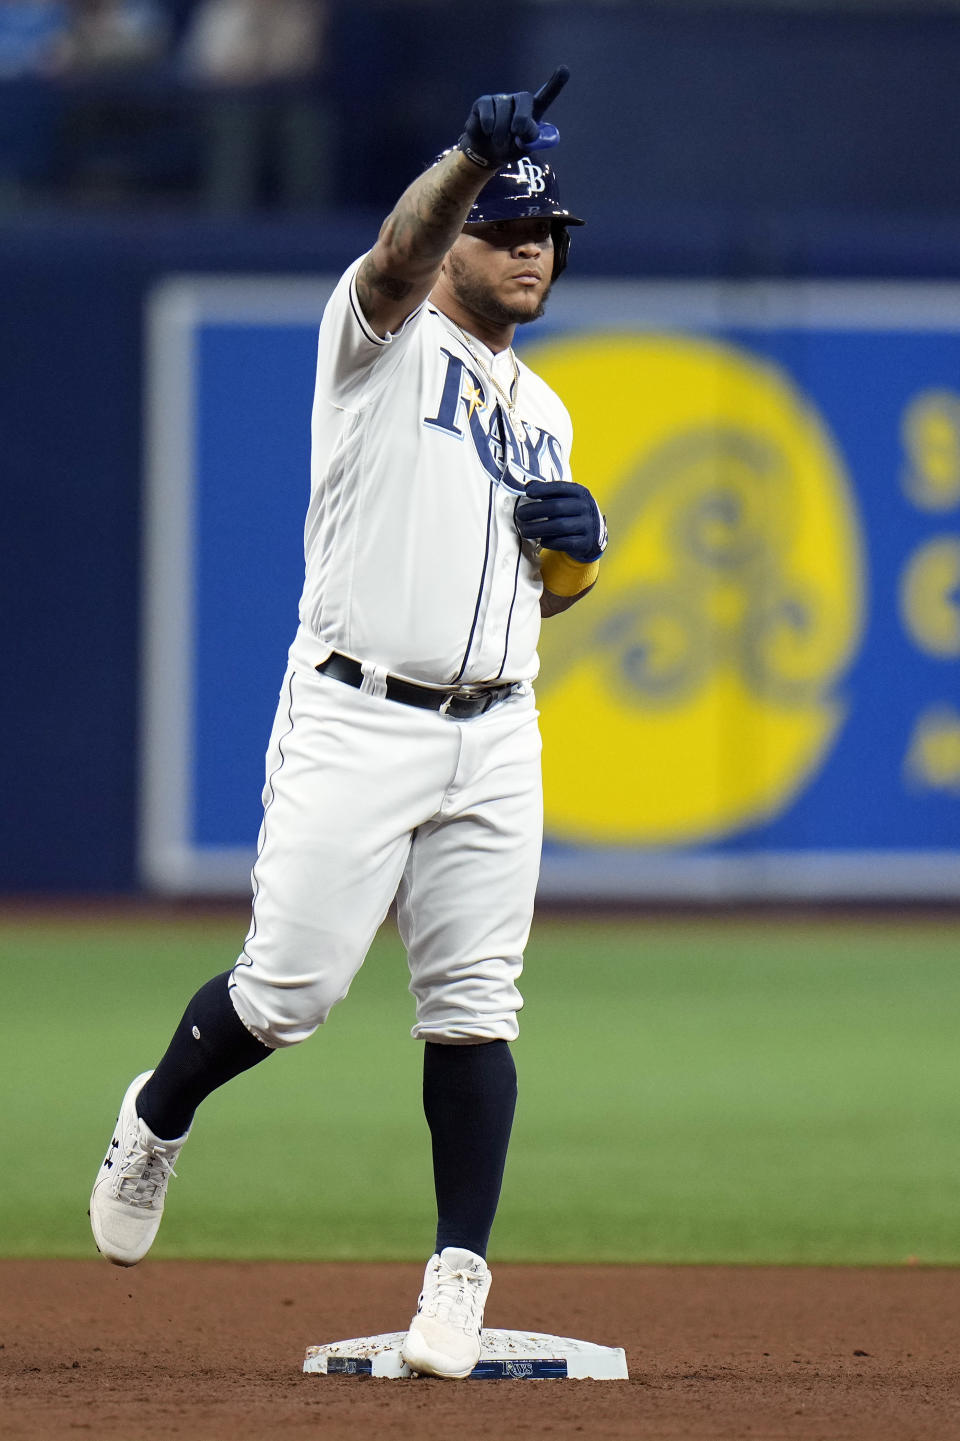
[424, 1040, 516, 1257]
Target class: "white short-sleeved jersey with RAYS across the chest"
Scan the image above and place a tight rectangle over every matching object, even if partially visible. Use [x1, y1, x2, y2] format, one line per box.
[293, 259, 572, 686]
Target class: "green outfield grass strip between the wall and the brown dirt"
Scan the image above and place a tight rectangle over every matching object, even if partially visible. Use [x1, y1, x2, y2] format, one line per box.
[0, 912, 960, 1264]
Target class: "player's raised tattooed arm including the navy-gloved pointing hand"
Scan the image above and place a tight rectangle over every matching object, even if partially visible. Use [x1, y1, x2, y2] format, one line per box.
[356, 66, 569, 336]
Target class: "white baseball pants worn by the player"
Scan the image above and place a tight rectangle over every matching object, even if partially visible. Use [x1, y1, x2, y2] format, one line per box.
[224, 664, 543, 1048]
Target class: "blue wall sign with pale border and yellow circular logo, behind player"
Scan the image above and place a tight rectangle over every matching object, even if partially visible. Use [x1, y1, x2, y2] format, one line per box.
[140, 277, 960, 901]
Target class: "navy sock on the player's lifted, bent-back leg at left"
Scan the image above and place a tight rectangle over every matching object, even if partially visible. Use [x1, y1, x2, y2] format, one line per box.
[137, 971, 274, 1141]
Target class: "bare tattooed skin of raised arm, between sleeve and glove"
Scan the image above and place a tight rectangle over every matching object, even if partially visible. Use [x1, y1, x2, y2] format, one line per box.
[356, 150, 489, 336]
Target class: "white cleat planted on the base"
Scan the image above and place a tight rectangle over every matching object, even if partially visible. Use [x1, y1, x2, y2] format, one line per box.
[401, 1246, 492, 1379]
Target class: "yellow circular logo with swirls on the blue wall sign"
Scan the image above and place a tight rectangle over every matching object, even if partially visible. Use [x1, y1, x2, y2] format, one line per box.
[525, 334, 863, 846]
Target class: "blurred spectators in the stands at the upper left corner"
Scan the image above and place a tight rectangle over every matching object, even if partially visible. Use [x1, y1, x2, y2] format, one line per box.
[0, 0, 330, 213]
